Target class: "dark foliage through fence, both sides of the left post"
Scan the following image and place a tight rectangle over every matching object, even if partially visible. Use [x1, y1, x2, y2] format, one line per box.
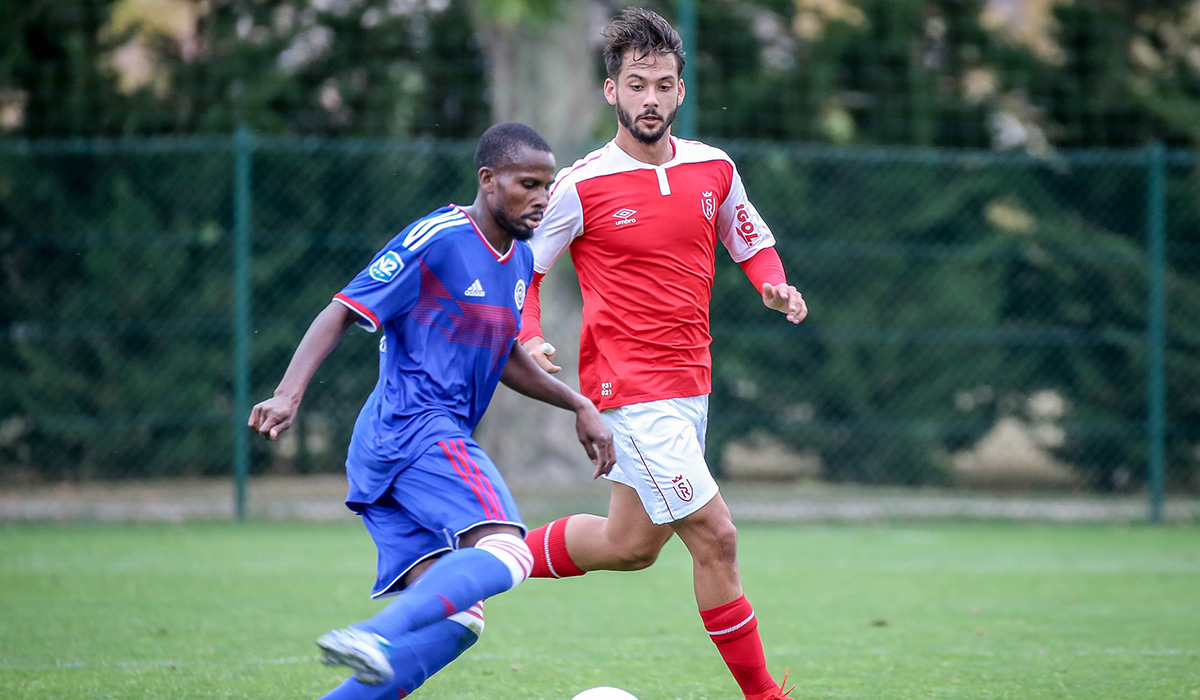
[0, 139, 474, 479]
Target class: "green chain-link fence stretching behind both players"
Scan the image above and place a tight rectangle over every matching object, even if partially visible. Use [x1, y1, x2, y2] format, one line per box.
[0, 132, 1200, 514]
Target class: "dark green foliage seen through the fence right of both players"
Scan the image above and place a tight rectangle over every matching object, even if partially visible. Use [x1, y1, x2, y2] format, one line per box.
[710, 146, 1200, 490]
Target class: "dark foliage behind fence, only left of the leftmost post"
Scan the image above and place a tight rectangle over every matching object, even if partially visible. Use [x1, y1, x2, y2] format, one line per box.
[0, 145, 232, 478]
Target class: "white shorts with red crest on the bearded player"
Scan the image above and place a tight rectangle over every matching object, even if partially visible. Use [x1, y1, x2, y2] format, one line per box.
[601, 396, 718, 525]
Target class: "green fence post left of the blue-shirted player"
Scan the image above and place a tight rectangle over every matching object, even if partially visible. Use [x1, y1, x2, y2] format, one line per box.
[233, 126, 254, 521]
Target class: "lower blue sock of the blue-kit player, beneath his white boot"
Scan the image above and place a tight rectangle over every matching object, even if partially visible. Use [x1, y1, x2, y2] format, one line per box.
[322, 620, 479, 700]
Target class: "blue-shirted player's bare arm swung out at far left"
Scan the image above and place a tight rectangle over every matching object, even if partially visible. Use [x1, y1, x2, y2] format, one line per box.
[248, 301, 359, 439]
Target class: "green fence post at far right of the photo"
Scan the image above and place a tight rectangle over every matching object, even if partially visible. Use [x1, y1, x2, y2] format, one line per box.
[1146, 142, 1166, 522]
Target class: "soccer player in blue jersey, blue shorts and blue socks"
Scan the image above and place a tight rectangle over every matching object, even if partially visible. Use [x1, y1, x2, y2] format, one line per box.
[250, 122, 614, 700]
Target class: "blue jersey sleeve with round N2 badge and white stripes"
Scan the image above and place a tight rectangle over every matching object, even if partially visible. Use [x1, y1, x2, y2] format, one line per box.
[334, 234, 421, 331]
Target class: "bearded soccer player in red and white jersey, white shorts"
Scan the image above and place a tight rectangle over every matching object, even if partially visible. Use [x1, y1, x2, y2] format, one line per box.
[521, 8, 808, 700]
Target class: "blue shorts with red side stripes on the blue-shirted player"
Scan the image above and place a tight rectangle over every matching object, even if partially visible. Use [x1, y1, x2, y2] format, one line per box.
[361, 437, 526, 598]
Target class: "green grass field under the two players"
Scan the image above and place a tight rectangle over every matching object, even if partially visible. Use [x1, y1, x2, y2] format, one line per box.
[0, 517, 1200, 700]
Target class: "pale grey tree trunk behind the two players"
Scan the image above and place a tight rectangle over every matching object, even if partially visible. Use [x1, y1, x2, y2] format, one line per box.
[475, 0, 616, 487]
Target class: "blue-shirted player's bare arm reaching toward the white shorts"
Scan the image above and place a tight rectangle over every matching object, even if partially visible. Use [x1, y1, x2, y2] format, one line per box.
[500, 340, 617, 478]
